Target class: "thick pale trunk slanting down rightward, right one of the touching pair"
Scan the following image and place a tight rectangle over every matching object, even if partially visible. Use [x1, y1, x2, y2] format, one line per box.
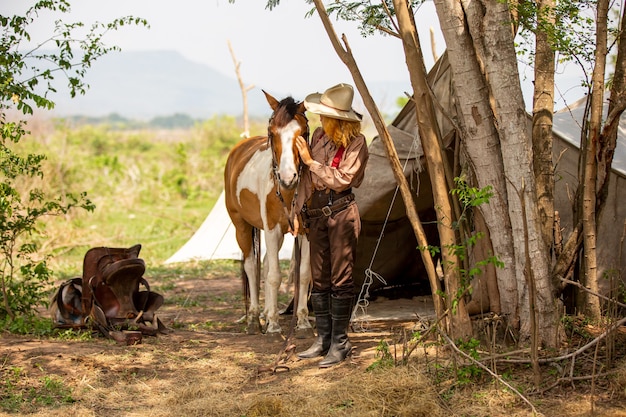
[462, 0, 559, 347]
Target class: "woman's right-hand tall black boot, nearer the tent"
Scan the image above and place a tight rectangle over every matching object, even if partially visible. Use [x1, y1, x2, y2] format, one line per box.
[320, 297, 353, 368]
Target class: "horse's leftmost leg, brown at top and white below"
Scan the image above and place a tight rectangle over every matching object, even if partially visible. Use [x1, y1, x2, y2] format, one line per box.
[236, 225, 261, 334]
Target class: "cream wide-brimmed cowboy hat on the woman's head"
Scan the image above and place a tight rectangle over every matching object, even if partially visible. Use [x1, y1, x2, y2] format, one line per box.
[304, 83, 363, 122]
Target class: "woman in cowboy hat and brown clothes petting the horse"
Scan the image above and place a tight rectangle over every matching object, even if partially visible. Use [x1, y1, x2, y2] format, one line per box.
[294, 84, 369, 368]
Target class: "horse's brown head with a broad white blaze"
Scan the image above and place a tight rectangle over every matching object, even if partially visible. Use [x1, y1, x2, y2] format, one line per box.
[263, 91, 309, 189]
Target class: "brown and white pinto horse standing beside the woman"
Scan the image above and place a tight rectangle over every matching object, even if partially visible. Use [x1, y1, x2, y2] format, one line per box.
[224, 91, 312, 334]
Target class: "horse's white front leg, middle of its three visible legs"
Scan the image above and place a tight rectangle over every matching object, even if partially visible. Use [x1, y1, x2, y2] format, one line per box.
[265, 225, 284, 334]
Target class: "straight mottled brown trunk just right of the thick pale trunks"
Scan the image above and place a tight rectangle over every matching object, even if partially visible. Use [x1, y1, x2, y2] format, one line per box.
[532, 0, 555, 251]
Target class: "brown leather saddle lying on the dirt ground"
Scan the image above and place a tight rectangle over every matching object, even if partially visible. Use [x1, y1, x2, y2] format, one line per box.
[51, 245, 168, 343]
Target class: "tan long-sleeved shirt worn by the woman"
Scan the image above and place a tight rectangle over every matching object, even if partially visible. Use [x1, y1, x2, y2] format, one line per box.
[295, 127, 369, 213]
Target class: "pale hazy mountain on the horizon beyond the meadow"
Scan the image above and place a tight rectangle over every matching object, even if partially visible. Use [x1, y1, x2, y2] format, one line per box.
[48, 51, 408, 120]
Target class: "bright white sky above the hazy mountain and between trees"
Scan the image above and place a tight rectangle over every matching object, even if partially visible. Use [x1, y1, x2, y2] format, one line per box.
[0, 0, 580, 110]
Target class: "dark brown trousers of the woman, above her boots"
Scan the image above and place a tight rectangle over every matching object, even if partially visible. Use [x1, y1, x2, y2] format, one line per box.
[309, 203, 361, 297]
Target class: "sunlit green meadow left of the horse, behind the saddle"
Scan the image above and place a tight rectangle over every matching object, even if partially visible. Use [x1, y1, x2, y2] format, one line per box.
[19, 116, 264, 280]
